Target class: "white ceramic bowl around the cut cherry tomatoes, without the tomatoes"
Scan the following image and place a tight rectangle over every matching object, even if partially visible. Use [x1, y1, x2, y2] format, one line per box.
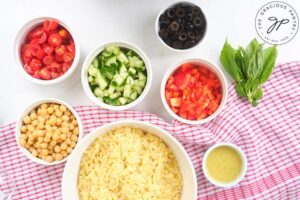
[14, 17, 80, 85]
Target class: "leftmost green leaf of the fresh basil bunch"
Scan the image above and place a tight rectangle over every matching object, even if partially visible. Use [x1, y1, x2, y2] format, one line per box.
[220, 40, 242, 81]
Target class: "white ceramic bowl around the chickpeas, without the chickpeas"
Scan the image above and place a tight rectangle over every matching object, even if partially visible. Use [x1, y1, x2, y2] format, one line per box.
[15, 98, 83, 165]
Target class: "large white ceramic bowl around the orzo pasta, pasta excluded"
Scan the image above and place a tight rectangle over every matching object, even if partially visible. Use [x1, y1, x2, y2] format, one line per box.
[62, 120, 197, 200]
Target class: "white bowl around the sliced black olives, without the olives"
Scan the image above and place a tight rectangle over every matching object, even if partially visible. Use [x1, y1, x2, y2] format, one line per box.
[155, 1, 208, 52]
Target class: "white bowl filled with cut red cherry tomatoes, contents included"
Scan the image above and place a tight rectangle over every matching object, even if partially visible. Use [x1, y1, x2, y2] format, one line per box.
[14, 17, 80, 85]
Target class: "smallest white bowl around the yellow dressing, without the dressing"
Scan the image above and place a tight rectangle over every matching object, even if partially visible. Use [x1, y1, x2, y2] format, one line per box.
[202, 142, 247, 187]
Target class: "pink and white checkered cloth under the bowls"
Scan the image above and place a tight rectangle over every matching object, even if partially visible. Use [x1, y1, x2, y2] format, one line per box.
[0, 62, 300, 200]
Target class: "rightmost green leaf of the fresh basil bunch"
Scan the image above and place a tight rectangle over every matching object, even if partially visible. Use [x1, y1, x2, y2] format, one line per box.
[259, 46, 277, 84]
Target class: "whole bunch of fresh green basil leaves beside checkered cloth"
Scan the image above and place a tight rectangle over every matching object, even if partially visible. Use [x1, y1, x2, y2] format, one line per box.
[220, 39, 277, 106]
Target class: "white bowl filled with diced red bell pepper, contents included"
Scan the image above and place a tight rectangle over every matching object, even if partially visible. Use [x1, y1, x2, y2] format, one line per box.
[161, 59, 227, 125]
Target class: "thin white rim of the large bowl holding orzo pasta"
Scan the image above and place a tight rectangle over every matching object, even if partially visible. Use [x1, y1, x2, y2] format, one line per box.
[61, 119, 198, 200]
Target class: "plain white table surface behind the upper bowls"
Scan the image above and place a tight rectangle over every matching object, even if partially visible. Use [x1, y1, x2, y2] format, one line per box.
[0, 0, 300, 125]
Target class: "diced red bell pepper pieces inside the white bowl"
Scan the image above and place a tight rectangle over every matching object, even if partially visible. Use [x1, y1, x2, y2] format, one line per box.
[165, 63, 222, 120]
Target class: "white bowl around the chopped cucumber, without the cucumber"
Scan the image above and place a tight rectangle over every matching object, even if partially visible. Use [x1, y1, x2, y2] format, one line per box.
[81, 41, 152, 111]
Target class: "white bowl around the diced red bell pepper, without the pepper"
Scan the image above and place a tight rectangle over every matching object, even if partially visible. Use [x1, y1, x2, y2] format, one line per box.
[160, 59, 228, 125]
